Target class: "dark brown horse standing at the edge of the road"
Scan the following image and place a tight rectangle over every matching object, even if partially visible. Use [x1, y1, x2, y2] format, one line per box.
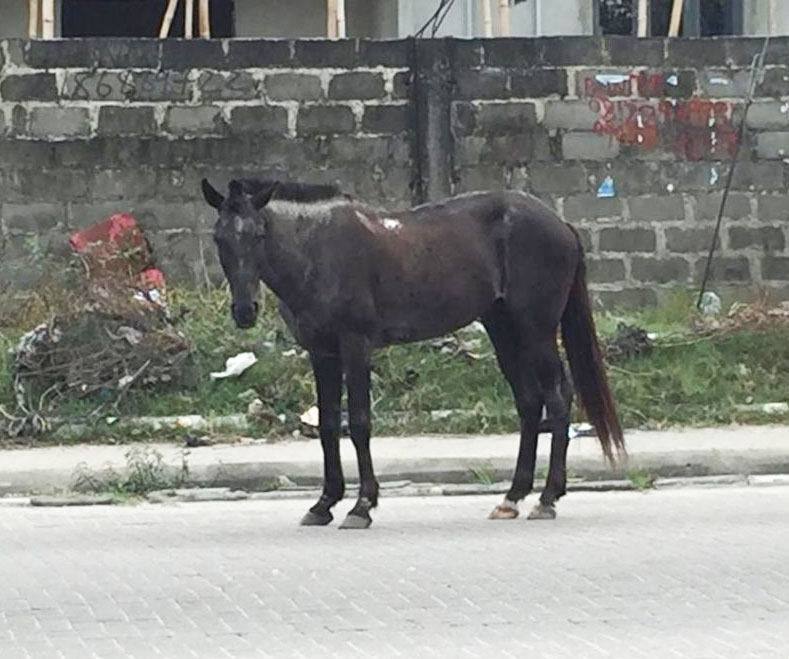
[203, 180, 624, 528]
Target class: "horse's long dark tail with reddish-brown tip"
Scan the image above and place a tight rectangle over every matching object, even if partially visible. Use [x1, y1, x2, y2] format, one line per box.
[562, 234, 626, 464]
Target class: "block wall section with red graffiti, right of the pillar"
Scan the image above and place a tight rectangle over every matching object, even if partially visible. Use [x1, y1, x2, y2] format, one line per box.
[444, 38, 789, 307]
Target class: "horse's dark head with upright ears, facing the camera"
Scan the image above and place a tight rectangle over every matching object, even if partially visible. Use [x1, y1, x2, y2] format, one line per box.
[203, 179, 279, 329]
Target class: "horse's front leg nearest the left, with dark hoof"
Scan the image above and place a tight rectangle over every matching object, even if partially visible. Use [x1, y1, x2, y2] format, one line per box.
[301, 353, 345, 526]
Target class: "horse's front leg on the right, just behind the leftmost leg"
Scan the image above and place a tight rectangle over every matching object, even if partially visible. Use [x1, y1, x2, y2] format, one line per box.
[340, 334, 378, 529]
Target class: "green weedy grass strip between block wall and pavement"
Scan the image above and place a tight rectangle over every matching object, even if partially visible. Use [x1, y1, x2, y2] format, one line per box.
[0, 290, 789, 441]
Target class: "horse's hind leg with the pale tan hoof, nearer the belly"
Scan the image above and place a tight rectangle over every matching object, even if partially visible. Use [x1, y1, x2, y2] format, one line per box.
[483, 309, 543, 519]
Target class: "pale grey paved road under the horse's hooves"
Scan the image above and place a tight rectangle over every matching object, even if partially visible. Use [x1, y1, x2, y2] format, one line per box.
[0, 487, 789, 659]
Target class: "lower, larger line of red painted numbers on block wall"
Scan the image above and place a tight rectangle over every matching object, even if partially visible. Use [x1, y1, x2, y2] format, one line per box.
[589, 96, 737, 160]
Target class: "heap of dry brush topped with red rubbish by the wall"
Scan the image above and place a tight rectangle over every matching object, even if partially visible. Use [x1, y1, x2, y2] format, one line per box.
[0, 214, 192, 437]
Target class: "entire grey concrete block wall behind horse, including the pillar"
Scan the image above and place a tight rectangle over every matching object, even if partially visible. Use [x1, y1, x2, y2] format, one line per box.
[0, 37, 789, 307]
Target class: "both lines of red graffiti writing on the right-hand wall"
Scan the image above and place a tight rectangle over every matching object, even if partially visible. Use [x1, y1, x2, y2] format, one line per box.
[584, 72, 737, 160]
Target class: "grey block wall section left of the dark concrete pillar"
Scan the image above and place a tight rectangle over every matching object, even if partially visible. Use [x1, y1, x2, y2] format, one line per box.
[0, 39, 413, 286]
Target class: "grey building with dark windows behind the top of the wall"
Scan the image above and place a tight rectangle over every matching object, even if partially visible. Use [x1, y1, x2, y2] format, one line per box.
[0, 0, 789, 39]
